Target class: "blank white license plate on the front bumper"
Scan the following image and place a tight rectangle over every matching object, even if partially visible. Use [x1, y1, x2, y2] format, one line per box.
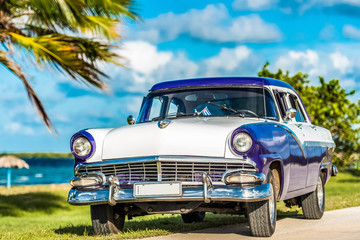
[134, 182, 182, 197]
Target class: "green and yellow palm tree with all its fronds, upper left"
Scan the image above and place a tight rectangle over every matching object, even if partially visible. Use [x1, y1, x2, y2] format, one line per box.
[0, 0, 138, 133]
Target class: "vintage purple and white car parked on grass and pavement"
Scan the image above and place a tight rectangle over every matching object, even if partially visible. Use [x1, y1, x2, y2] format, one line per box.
[68, 77, 337, 236]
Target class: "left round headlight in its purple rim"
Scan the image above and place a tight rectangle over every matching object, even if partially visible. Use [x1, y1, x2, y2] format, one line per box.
[70, 131, 95, 160]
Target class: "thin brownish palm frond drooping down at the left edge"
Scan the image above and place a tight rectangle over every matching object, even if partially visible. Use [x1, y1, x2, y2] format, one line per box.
[0, 50, 56, 134]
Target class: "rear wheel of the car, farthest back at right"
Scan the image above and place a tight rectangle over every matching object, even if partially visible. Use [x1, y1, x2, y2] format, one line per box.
[301, 176, 325, 219]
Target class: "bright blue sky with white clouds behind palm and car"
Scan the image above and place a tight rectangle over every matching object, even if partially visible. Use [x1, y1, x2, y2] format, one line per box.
[0, 0, 360, 152]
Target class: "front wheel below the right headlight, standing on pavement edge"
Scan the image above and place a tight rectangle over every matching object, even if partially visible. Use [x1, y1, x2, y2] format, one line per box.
[246, 171, 277, 237]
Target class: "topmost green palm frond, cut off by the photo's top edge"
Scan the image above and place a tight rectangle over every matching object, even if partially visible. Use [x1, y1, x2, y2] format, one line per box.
[12, 0, 137, 40]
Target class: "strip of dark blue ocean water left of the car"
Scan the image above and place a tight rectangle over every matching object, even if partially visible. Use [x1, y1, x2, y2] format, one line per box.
[0, 158, 74, 186]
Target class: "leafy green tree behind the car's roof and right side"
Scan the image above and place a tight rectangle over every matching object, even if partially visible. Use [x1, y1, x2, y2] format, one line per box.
[258, 63, 360, 166]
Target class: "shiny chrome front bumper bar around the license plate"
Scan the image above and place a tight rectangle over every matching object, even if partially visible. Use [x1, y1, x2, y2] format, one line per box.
[67, 183, 271, 205]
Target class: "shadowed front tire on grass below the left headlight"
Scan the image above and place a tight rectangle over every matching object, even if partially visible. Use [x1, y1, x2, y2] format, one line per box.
[90, 204, 125, 235]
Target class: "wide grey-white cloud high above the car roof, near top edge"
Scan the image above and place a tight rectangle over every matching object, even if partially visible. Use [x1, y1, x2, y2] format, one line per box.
[135, 4, 281, 43]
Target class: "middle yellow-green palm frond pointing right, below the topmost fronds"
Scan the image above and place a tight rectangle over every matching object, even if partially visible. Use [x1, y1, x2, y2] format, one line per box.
[10, 33, 121, 90]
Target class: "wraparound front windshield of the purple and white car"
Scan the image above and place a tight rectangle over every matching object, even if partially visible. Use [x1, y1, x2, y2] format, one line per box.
[138, 87, 277, 123]
